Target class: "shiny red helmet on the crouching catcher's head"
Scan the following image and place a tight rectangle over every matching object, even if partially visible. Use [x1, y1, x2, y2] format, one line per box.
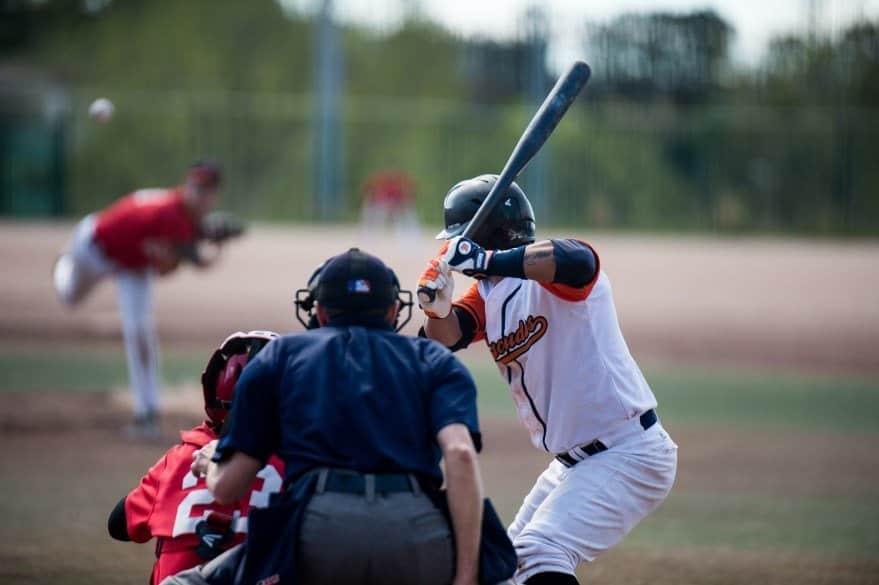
[201, 331, 279, 429]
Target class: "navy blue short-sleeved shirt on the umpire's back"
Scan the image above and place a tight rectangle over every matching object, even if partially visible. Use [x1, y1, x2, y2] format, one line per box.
[215, 318, 479, 485]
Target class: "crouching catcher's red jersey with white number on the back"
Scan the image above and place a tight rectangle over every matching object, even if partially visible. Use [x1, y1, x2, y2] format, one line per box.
[125, 424, 284, 583]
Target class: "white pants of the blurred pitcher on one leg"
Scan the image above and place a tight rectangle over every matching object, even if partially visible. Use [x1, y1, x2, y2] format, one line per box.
[53, 215, 159, 416]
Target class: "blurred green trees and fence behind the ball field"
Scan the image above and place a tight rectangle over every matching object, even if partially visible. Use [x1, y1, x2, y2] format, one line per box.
[0, 0, 879, 234]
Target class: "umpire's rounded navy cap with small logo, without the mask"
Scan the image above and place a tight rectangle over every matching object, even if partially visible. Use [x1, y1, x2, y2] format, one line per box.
[316, 248, 400, 313]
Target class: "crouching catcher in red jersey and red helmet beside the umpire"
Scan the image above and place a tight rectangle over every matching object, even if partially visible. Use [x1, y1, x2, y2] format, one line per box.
[107, 331, 284, 585]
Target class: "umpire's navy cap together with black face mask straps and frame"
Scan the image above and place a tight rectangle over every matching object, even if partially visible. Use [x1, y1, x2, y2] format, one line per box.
[293, 248, 413, 331]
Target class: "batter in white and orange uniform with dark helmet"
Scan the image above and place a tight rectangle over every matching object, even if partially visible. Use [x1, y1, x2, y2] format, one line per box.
[418, 175, 677, 585]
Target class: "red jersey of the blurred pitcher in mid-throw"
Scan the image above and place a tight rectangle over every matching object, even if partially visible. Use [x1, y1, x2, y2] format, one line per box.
[95, 189, 196, 270]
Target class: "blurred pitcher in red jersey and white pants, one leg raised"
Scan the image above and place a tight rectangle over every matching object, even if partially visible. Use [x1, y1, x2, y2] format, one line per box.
[53, 161, 227, 437]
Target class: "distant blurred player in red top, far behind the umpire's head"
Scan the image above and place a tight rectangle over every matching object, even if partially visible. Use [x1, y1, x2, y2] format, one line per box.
[362, 169, 418, 239]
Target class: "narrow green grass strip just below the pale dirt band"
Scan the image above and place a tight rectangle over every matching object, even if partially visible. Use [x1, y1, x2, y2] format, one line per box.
[0, 347, 879, 433]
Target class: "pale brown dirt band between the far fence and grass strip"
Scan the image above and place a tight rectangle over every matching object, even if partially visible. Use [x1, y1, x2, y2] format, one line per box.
[0, 223, 879, 371]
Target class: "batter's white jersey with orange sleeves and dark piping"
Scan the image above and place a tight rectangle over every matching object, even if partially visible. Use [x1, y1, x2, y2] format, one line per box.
[455, 258, 656, 453]
